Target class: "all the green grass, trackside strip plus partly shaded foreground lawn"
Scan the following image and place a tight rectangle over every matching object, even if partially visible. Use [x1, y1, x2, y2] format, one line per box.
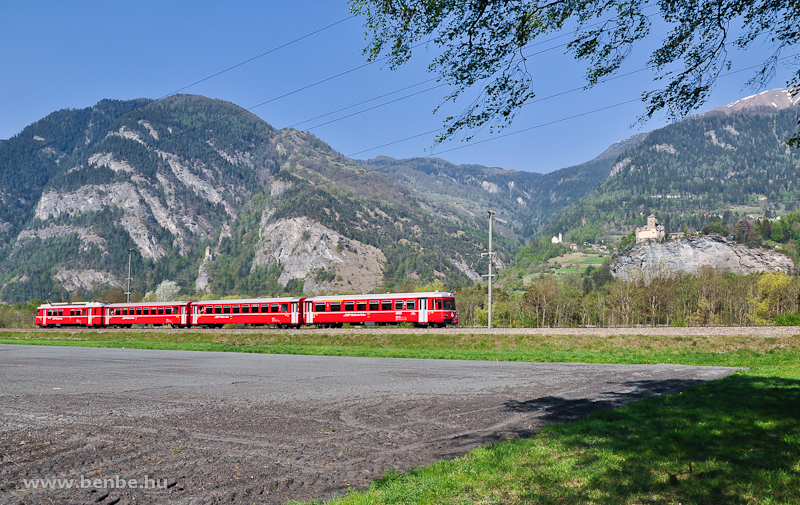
[0, 331, 800, 504]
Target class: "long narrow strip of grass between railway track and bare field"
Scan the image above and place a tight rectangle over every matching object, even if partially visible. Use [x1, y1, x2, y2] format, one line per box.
[0, 329, 800, 367]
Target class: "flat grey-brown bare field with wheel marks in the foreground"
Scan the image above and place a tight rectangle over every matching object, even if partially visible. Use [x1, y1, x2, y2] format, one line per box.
[0, 345, 734, 505]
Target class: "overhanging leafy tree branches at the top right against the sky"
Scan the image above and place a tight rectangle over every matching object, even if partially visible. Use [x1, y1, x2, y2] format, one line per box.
[350, 0, 800, 146]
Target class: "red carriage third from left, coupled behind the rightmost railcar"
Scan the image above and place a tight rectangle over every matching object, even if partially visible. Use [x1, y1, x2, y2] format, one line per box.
[191, 297, 303, 328]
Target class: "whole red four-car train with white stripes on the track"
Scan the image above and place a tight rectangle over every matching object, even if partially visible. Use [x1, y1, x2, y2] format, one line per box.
[36, 291, 458, 328]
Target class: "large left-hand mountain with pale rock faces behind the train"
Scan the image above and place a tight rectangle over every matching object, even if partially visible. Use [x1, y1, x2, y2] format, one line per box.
[0, 95, 500, 301]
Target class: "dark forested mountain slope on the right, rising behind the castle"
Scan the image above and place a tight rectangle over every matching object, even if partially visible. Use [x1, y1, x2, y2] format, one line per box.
[547, 92, 800, 246]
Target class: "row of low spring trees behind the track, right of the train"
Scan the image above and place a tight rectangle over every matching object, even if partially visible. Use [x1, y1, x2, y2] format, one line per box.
[456, 264, 800, 327]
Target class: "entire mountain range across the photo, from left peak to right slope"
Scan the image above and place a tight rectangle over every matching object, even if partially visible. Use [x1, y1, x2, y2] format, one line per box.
[0, 90, 800, 301]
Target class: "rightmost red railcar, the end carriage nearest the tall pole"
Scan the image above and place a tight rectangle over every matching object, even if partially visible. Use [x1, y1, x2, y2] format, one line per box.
[303, 291, 457, 328]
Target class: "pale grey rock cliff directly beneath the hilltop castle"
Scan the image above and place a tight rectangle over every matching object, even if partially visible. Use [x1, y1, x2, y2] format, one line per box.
[611, 235, 794, 280]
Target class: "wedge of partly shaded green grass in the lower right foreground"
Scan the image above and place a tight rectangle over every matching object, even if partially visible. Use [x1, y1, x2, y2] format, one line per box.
[314, 365, 800, 505]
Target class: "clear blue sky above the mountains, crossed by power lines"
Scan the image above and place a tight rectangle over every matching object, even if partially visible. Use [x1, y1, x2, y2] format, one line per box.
[0, 0, 790, 173]
